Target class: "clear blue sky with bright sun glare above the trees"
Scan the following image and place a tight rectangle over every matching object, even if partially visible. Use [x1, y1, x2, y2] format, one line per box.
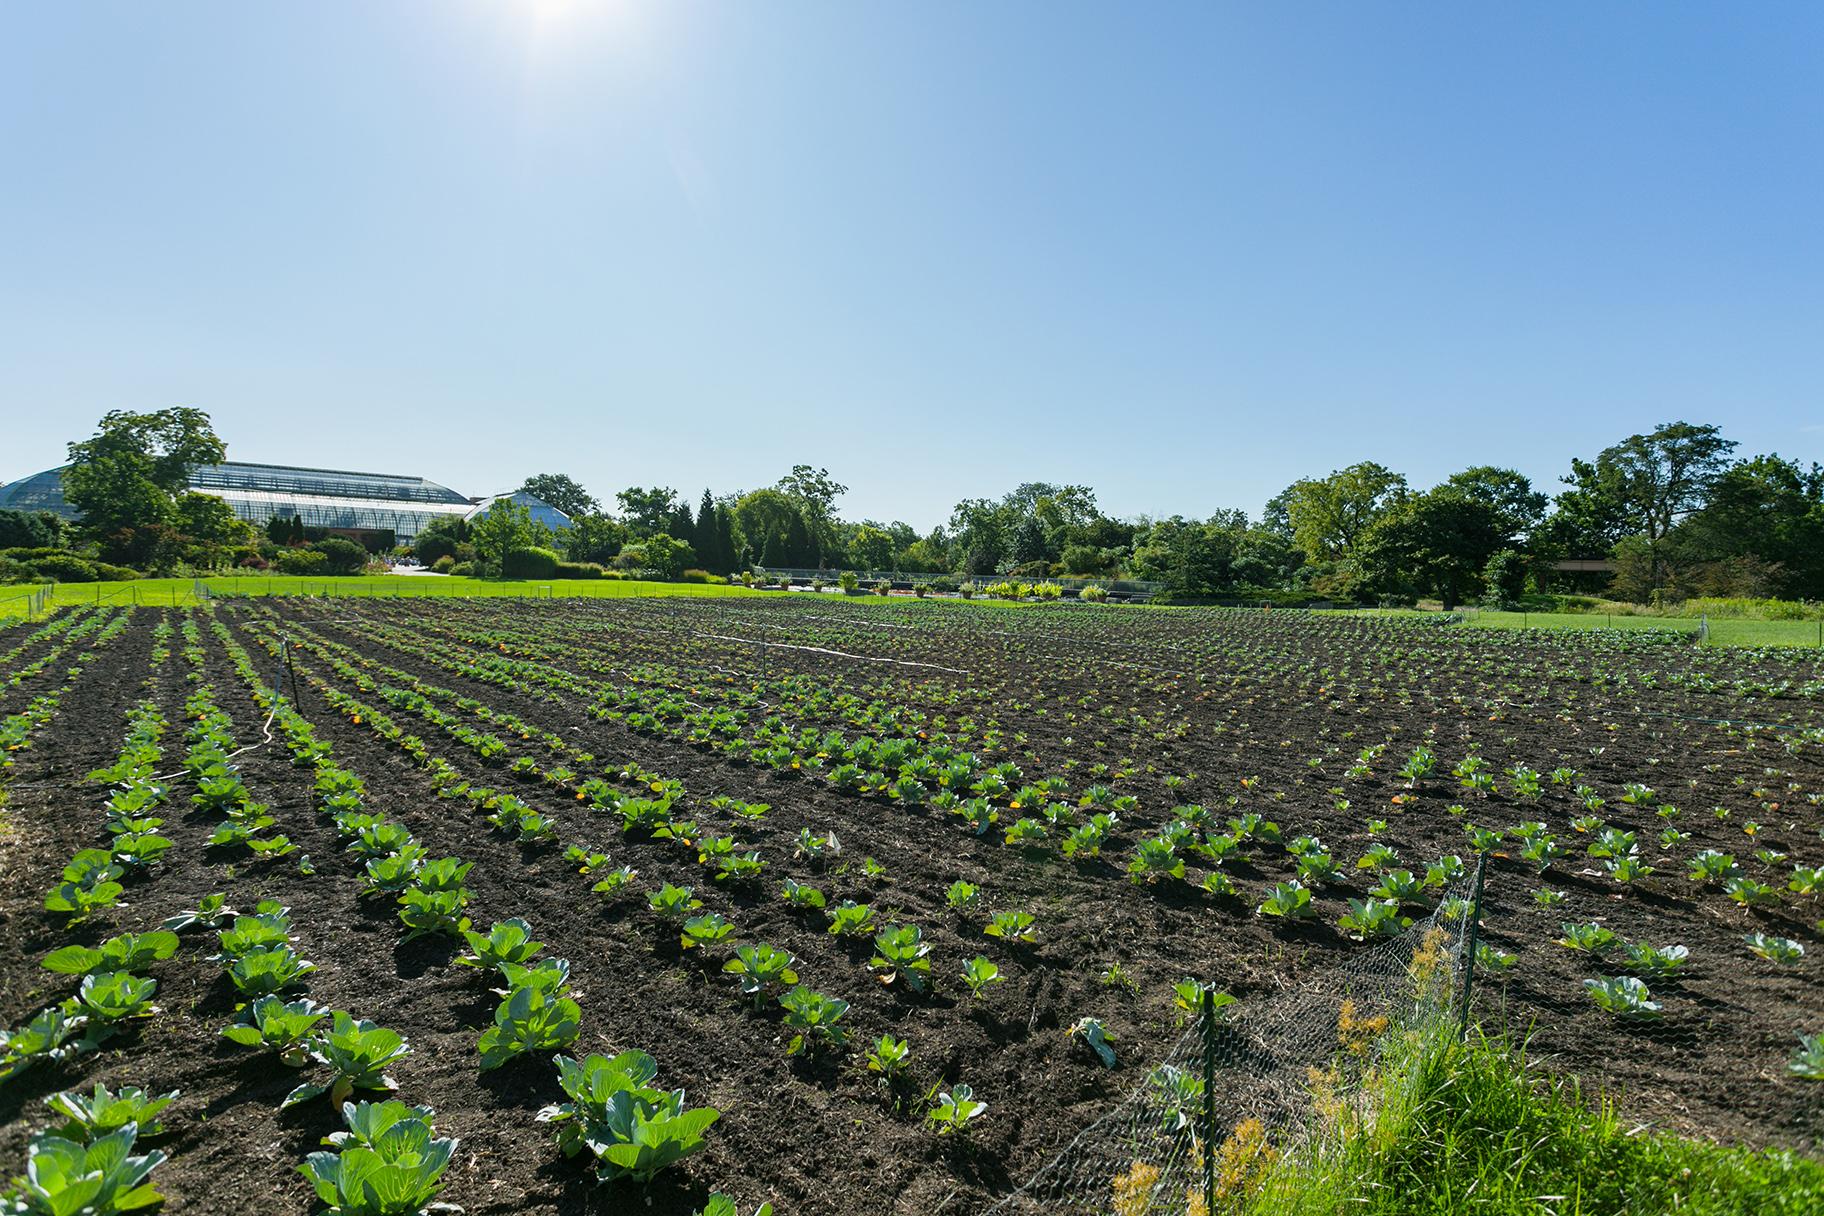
[0, 0, 1824, 527]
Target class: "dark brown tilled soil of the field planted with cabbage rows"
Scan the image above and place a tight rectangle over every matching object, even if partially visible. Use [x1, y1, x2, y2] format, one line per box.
[0, 596, 1824, 1216]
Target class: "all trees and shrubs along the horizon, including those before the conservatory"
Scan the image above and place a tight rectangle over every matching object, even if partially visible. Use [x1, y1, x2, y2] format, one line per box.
[0, 408, 1824, 605]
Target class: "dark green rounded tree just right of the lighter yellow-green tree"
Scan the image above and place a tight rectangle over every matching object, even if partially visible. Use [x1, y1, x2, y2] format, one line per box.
[1355, 485, 1507, 609]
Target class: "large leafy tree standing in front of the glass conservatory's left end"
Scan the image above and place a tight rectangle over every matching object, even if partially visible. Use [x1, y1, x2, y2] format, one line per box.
[64, 407, 228, 563]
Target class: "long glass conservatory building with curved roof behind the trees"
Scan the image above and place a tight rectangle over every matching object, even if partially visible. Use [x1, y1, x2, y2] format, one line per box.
[0, 461, 474, 545]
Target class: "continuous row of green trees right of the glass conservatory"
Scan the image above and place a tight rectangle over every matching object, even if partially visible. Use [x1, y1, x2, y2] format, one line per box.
[503, 421, 1824, 605]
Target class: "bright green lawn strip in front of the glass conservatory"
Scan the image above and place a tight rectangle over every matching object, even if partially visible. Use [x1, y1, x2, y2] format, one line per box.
[0, 574, 766, 620]
